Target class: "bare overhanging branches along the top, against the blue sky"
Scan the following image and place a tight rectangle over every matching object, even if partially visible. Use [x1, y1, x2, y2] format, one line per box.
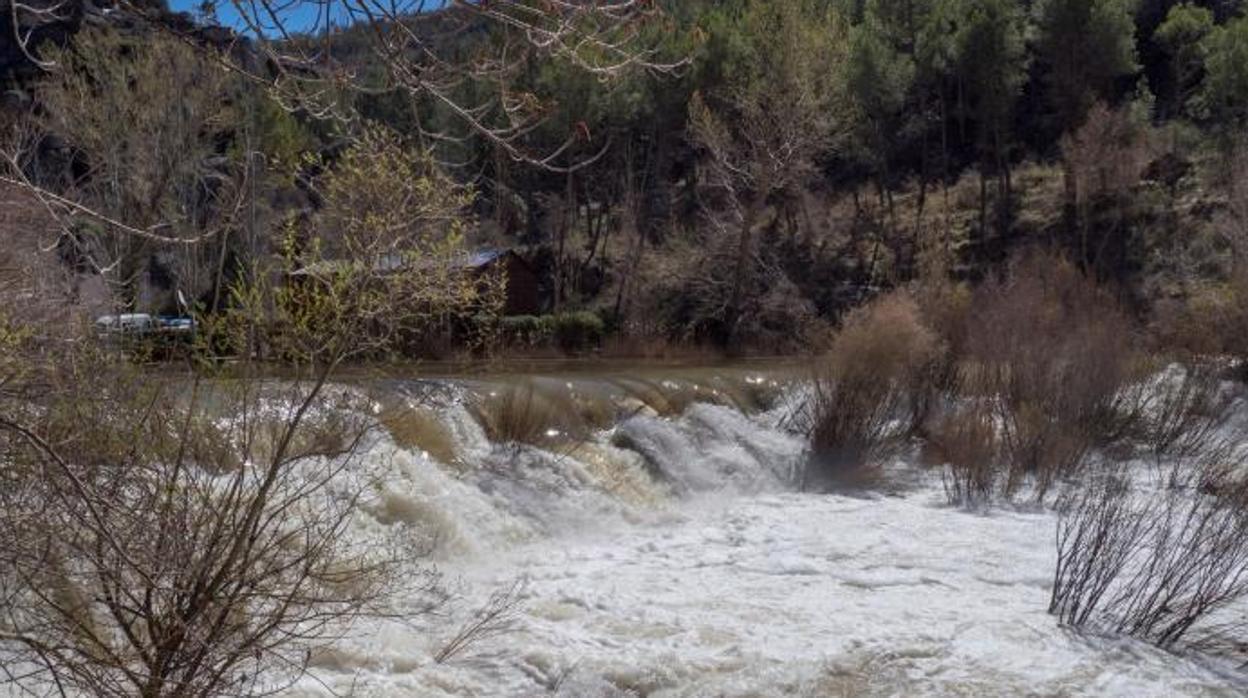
[10, 0, 685, 171]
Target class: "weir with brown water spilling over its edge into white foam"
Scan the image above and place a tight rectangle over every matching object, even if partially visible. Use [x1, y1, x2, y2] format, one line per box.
[366, 368, 804, 554]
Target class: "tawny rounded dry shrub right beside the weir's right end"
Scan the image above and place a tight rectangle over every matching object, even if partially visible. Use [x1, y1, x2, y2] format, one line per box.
[805, 291, 941, 484]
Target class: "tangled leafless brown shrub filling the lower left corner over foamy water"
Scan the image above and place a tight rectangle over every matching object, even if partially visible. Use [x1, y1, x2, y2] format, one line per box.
[0, 367, 433, 696]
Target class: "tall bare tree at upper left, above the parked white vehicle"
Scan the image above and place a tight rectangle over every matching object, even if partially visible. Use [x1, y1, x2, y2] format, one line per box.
[0, 29, 243, 308]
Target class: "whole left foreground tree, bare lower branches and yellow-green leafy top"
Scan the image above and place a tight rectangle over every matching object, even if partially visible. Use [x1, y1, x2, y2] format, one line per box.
[0, 126, 492, 697]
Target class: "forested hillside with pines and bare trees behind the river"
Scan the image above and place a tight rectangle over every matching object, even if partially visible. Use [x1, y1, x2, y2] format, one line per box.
[0, 0, 1248, 353]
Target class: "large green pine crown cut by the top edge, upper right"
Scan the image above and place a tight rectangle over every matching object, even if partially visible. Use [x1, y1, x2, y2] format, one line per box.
[1035, 0, 1138, 131]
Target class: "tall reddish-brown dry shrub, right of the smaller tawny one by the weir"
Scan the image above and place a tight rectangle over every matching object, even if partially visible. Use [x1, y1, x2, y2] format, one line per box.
[965, 252, 1137, 499]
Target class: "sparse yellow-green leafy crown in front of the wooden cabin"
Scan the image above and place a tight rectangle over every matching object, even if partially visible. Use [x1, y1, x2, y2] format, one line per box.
[200, 125, 504, 366]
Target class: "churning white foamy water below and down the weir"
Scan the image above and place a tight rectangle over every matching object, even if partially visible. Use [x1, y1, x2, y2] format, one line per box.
[296, 374, 1246, 698]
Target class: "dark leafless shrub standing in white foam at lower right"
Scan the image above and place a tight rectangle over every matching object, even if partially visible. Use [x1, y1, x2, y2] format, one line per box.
[1050, 471, 1248, 648]
